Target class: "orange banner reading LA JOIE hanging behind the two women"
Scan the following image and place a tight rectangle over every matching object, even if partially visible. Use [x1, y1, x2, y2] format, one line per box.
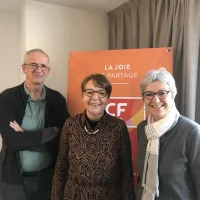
[67, 48, 173, 186]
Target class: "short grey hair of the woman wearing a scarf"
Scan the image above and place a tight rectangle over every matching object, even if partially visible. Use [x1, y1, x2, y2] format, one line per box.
[140, 67, 177, 98]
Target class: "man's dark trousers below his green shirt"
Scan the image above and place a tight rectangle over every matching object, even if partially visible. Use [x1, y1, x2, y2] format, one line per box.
[2, 169, 54, 200]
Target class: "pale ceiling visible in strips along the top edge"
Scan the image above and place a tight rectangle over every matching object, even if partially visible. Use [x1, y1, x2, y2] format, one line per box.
[0, 0, 128, 12]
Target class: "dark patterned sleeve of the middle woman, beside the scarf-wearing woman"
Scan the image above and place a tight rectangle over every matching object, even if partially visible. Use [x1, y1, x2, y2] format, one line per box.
[120, 124, 135, 200]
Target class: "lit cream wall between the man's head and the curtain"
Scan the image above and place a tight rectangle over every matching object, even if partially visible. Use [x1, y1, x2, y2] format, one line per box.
[22, 0, 108, 96]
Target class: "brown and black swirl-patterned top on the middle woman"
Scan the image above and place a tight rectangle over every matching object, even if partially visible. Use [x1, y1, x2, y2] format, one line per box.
[51, 112, 134, 200]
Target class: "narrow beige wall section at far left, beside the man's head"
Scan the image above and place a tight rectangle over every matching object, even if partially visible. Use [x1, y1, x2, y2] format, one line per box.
[0, 12, 21, 92]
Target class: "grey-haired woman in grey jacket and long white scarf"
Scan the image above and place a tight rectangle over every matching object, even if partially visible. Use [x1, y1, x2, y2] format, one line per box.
[136, 68, 200, 200]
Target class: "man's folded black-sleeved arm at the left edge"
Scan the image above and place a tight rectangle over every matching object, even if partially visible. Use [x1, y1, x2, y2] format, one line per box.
[0, 93, 57, 150]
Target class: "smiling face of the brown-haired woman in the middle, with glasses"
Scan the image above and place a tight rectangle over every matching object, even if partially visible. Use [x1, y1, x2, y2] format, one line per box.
[83, 80, 108, 120]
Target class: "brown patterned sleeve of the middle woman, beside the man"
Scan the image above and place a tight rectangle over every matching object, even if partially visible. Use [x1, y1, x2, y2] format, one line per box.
[51, 121, 71, 200]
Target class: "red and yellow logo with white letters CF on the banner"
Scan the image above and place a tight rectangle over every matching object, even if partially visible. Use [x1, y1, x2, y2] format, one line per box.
[106, 97, 145, 128]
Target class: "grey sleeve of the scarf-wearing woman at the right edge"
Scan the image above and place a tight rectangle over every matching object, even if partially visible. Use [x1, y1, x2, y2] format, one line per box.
[189, 127, 200, 200]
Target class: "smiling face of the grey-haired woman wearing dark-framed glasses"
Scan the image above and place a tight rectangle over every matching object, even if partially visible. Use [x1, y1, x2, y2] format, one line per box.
[143, 82, 174, 121]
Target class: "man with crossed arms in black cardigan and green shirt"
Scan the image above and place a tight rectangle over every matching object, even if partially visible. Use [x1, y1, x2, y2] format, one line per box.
[0, 49, 69, 200]
